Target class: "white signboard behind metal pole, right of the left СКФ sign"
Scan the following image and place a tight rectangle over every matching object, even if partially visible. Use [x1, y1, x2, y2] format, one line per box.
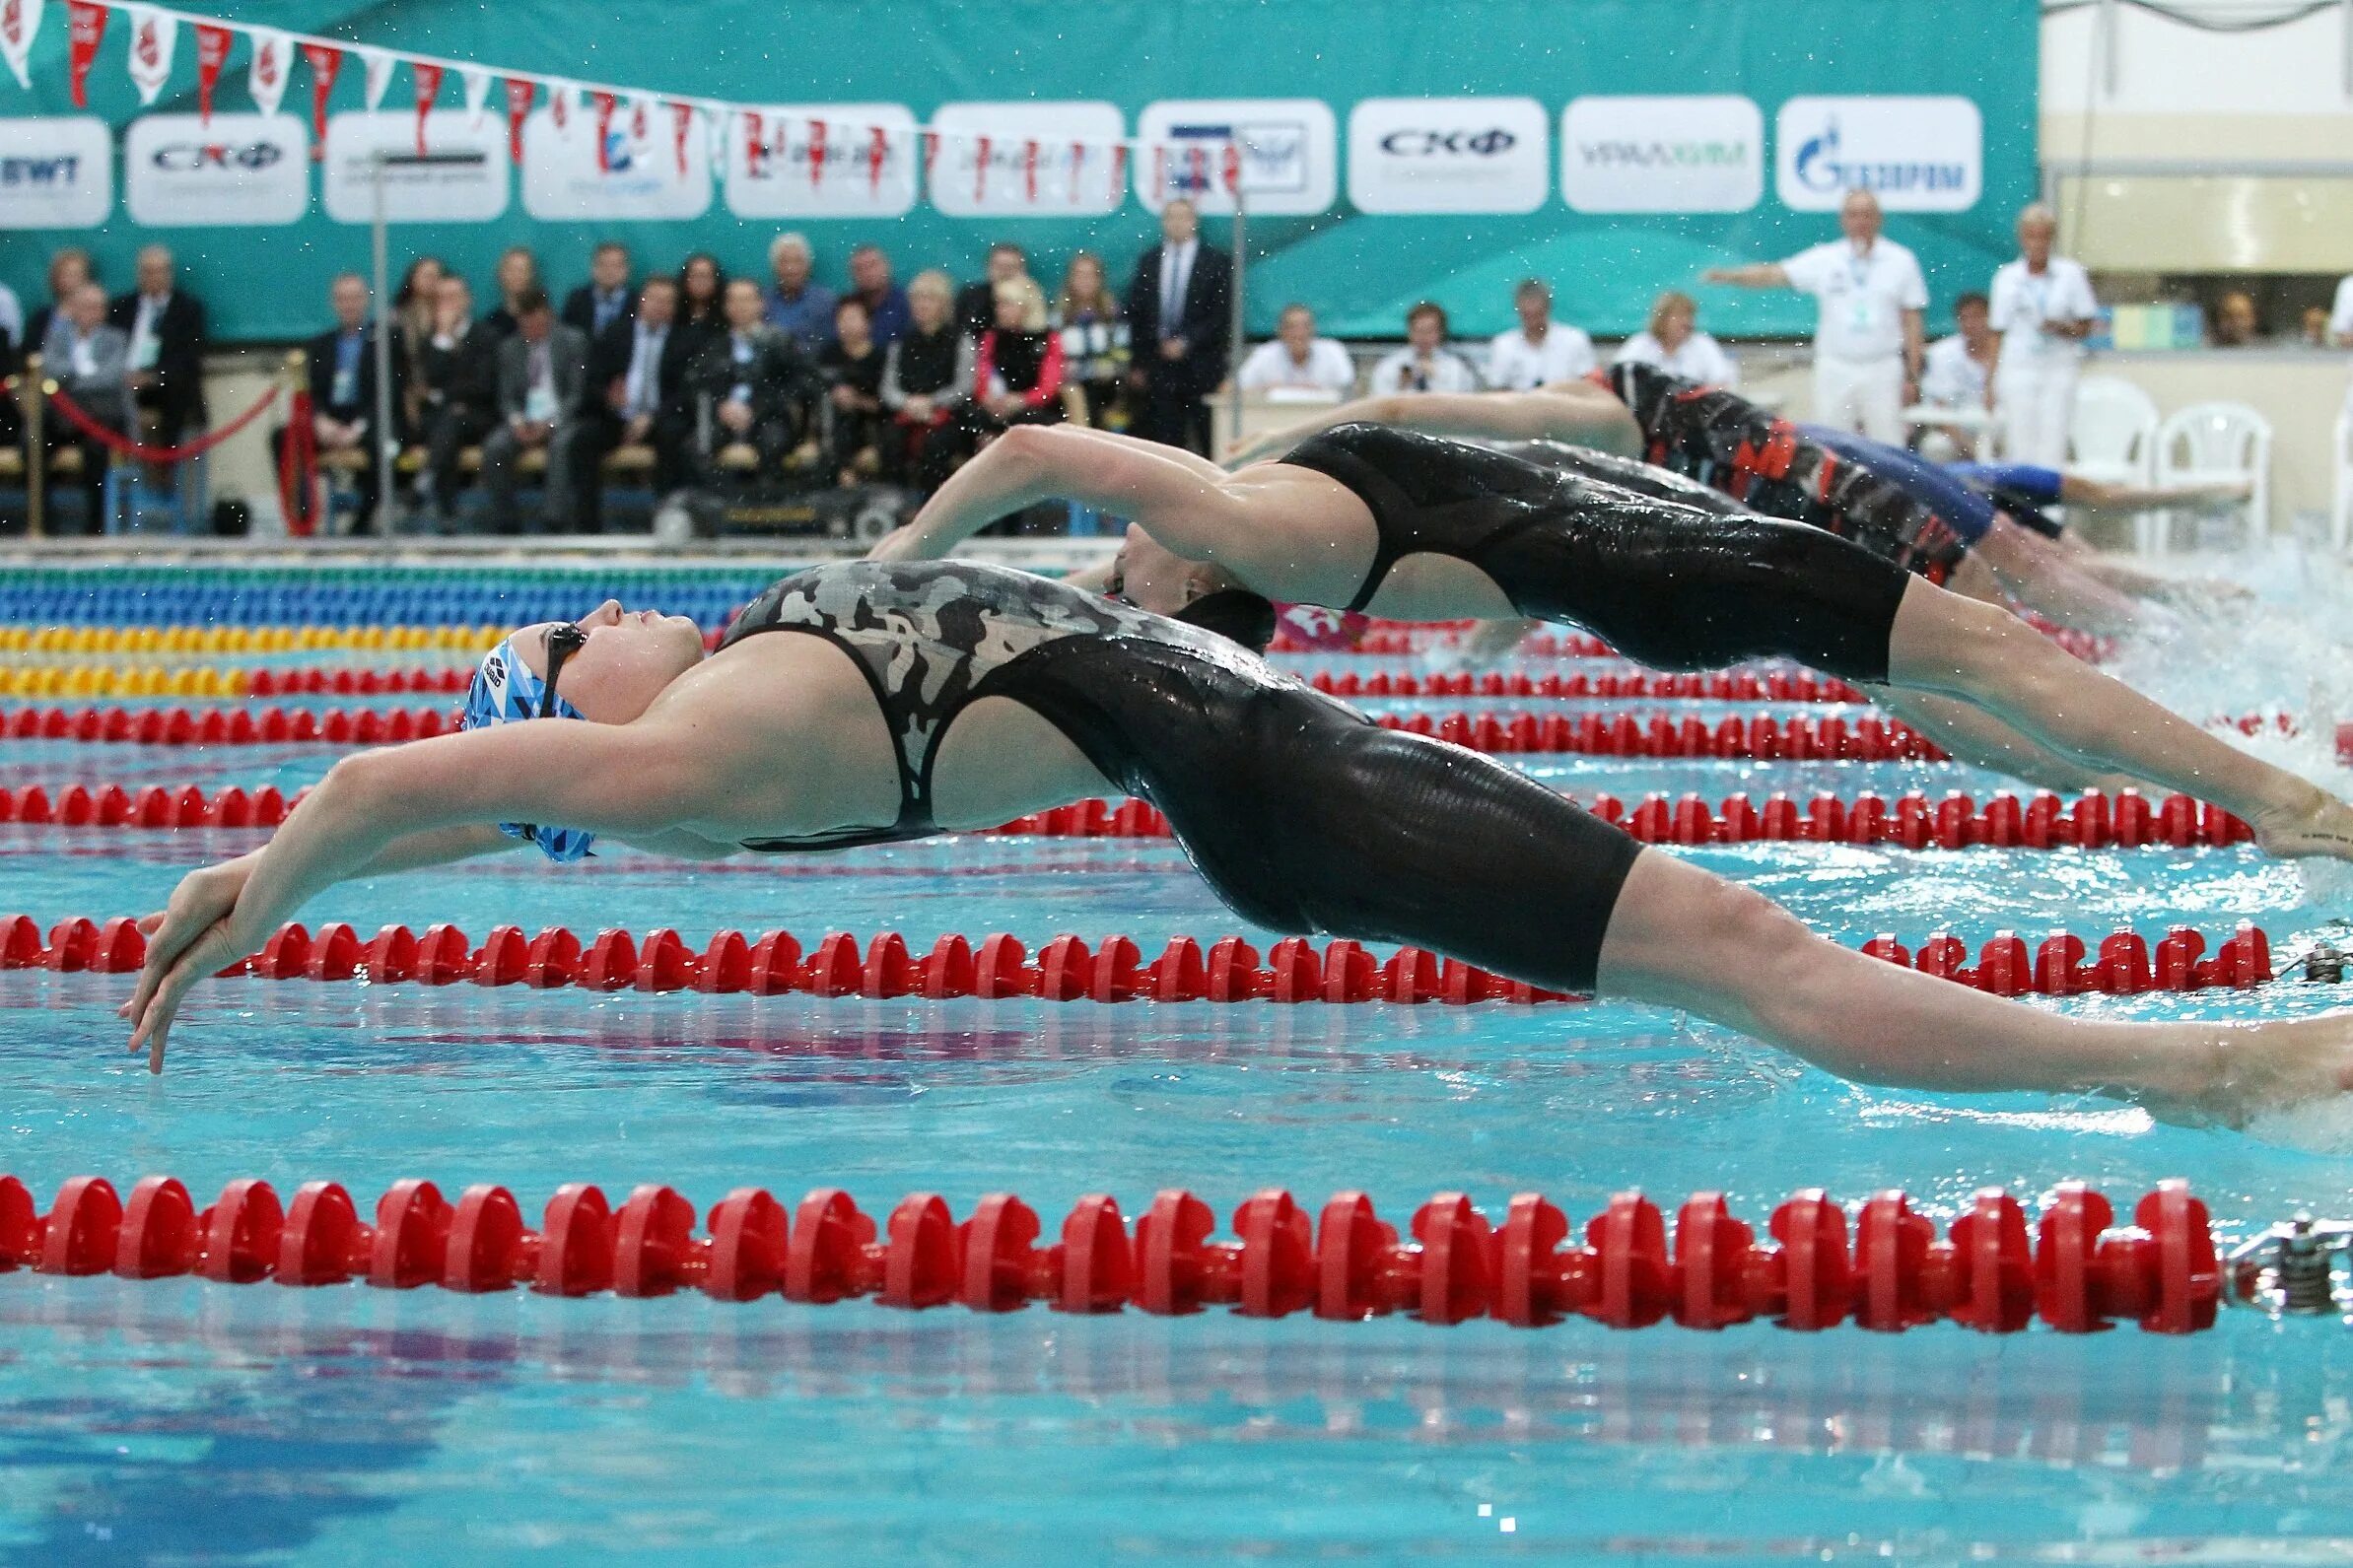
[320, 108, 509, 224]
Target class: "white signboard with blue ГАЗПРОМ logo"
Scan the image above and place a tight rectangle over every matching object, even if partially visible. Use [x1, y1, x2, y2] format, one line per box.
[1774, 97, 1986, 212]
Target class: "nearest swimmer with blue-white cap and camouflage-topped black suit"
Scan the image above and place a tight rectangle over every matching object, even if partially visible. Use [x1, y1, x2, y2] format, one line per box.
[122, 562, 2353, 1122]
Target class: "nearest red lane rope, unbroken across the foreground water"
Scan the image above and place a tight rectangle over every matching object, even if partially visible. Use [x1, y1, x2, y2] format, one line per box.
[0, 1176, 2224, 1332]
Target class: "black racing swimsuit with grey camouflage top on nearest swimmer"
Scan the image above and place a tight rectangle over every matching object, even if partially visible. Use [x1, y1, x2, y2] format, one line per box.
[718, 562, 1640, 992]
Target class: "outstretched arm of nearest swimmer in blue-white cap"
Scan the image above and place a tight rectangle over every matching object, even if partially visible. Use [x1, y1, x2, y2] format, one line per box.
[122, 719, 710, 1072]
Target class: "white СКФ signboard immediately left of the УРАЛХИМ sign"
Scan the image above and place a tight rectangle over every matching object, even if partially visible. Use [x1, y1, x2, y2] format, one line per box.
[1349, 99, 1553, 212]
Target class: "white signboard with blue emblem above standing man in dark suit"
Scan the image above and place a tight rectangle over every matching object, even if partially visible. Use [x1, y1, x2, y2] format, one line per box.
[1135, 99, 1339, 216]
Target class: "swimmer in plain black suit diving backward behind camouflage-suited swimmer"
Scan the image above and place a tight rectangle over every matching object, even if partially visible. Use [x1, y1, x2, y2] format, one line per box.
[873, 426, 2353, 860]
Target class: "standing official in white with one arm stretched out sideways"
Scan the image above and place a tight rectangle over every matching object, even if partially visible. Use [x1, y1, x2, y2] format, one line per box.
[1706, 190, 1927, 442]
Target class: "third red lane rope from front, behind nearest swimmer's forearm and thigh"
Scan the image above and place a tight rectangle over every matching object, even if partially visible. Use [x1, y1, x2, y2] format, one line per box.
[0, 783, 2254, 849]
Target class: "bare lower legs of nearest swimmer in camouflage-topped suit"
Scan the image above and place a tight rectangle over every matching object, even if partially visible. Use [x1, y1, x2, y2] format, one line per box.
[1600, 851, 2353, 1124]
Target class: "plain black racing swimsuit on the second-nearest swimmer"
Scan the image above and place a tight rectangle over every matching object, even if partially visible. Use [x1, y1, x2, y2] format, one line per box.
[1282, 426, 1905, 682]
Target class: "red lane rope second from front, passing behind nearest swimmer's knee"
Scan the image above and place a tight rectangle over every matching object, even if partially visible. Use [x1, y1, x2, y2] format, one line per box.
[0, 915, 2273, 1006]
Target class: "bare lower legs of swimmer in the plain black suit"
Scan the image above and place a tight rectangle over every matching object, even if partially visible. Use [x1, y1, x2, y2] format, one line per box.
[1887, 579, 2353, 860]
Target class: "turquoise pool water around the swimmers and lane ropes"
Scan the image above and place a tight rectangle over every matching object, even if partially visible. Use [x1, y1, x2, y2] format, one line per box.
[0, 567, 2353, 1563]
